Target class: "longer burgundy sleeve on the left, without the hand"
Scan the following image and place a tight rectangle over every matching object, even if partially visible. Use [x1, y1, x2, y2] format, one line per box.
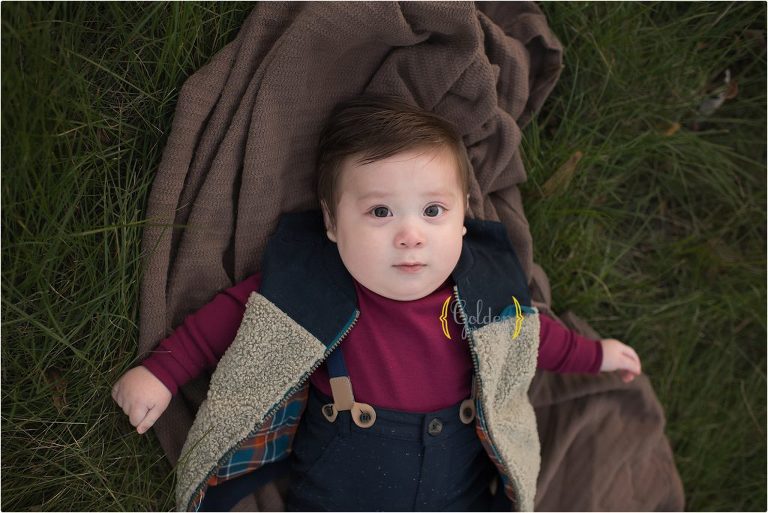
[141, 273, 261, 395]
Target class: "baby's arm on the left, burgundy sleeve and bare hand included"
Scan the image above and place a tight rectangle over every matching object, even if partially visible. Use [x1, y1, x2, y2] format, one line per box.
[112, 273, 261, 434]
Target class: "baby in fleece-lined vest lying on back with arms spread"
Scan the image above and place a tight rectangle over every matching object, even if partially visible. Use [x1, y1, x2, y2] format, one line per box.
[112, 96, 641, 511]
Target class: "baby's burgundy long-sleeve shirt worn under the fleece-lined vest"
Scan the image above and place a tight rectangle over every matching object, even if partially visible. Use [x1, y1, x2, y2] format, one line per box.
[142, 273, 603, 412]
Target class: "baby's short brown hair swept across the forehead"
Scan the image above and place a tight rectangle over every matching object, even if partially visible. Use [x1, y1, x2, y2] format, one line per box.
[317, 94, 472, 227]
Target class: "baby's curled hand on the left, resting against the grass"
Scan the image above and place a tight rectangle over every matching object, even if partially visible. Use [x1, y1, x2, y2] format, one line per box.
[112, 366, 172, 435]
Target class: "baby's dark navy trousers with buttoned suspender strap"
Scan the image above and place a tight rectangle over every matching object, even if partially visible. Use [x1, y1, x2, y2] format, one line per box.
[286, 340, 511, 511]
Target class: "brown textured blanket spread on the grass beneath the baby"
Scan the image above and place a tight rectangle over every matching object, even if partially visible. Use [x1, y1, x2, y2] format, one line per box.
[139, 2, 683, 510]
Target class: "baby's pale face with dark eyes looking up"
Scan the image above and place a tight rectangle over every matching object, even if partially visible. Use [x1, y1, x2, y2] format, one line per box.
[326, 148, 466, 301]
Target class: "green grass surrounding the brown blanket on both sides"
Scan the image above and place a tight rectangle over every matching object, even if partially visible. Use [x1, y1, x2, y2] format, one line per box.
[0, 2, 766, 510]
